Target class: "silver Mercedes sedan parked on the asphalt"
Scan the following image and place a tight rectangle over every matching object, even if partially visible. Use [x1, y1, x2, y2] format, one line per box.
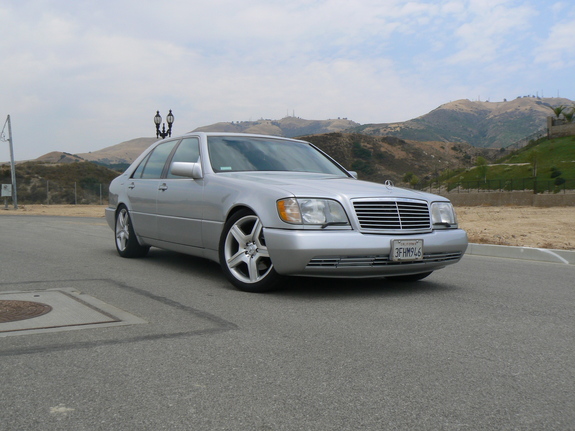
[106, 133, 467, 292]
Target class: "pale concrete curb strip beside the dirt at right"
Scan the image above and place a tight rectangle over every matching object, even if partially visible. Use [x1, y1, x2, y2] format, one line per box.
[465, 244, 575, 265]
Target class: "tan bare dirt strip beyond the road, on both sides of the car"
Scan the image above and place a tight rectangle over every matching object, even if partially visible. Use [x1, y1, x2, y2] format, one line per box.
[0, 205, 575, 250]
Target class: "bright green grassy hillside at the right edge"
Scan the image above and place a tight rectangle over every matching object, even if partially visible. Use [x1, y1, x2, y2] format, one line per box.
[438, 136, 575, 192]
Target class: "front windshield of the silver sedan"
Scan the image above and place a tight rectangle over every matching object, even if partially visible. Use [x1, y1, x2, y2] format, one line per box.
[208, 136, 347, 176]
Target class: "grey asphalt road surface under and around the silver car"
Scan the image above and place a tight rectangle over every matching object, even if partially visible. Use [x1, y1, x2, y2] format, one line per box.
[0, 216, 575, 431]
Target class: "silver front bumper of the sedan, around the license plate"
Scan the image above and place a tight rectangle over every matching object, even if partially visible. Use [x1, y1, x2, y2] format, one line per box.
[264, 229, 467, 277]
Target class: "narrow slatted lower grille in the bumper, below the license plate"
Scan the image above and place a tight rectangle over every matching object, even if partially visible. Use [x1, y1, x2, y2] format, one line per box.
[307, 252, 462, 269]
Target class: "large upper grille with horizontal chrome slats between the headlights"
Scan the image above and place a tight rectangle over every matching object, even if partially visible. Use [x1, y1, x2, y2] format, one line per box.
[353, 199, 431, 233]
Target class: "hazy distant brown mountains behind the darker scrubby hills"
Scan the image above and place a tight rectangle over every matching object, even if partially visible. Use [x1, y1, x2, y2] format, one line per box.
[32, 96, 573, 166]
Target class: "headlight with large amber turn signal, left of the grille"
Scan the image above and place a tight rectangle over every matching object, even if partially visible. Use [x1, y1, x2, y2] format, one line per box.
[277, 198, 349, 227]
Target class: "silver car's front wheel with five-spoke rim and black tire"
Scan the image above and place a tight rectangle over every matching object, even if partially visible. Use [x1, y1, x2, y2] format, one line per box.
[219, 209, 283, 293]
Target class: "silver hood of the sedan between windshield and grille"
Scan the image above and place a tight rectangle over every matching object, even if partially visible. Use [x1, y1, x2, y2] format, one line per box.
[217, 172, 448, 202]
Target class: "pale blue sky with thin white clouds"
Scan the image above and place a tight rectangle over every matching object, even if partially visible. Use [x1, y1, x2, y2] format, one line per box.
[0, 0, 575, 161]
